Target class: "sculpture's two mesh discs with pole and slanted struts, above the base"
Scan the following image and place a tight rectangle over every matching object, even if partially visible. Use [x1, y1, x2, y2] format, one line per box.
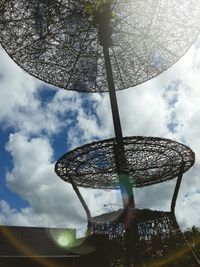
[0, 0, 200, 266]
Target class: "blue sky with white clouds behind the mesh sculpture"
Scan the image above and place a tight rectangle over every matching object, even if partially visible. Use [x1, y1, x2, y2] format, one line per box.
[0, 35, 200, 237]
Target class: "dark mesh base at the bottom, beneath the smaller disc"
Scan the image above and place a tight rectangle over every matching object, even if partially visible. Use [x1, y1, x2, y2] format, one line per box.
[92, 209, 196, 267]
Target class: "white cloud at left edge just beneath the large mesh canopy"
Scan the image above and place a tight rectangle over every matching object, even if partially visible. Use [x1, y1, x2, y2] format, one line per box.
[0, 48, 38, 127]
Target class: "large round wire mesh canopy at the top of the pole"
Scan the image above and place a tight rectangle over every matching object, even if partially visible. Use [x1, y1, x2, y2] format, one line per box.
[0, 0, 200, 92]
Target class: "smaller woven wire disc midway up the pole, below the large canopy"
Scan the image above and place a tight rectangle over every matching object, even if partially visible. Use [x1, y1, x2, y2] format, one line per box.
[55, 136, 195, 189]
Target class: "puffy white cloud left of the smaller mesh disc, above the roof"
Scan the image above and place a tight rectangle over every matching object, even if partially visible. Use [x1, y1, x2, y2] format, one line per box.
[3, 134, 84, 225]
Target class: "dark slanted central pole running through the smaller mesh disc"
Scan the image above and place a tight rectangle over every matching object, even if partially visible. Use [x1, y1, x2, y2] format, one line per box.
[103, 45, 135, 209]
